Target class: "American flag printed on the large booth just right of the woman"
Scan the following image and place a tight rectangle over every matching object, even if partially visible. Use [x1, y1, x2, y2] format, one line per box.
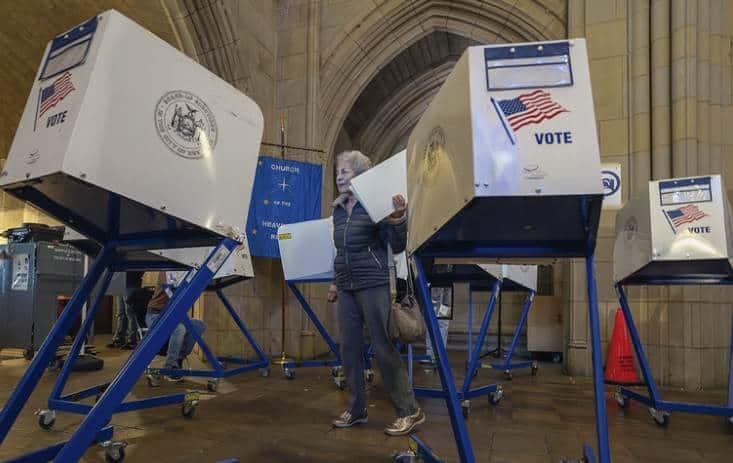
[497, 90, 570, 132]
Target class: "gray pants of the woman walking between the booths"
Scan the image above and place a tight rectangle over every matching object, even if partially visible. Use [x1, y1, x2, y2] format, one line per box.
[338, 285, 417, 417]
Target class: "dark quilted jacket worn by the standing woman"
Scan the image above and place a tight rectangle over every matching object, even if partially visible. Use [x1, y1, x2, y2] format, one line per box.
[333, 200, 407, 291]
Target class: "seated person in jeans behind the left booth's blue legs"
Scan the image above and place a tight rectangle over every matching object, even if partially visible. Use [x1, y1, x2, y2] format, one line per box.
[145, 272, 206, 382]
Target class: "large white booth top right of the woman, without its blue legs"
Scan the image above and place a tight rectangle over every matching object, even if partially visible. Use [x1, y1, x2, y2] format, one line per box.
[407, 40, 602, 260]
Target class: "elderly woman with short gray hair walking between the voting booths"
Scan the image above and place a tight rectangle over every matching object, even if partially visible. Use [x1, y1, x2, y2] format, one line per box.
[328, 151, 425, 436]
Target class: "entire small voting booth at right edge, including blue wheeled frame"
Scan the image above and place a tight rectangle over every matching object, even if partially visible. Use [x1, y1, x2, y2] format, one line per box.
[613, 175, 733, 426]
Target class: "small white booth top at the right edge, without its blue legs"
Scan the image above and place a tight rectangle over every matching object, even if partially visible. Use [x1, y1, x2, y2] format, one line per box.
[613, 175, 733, 283]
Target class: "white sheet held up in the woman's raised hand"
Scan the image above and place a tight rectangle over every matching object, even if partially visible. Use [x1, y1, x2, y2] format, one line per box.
[351, 150, 407, 223]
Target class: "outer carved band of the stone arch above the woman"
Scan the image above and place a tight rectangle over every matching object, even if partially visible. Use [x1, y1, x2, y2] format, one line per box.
[320, 0, 567, 158]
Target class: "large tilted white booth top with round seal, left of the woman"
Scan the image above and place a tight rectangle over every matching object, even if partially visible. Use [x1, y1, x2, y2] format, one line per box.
[0, 11, 263, 246]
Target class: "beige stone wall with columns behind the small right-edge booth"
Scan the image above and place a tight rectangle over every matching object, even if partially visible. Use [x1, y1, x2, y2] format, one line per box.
[564, 0, 733, 388]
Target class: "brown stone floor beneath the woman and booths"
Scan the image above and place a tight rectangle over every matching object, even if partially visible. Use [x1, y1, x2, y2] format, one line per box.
[0, 338, 733, 463]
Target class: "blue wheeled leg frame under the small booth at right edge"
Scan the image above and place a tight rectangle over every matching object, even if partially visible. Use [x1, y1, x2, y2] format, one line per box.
[615, 278, 733, 424]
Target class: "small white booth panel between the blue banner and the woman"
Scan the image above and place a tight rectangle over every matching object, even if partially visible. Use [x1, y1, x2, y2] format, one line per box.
[277, 217, 336, 281]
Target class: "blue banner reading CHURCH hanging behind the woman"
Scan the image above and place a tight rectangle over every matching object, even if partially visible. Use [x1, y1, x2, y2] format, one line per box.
[247, 156, 323, 258]
